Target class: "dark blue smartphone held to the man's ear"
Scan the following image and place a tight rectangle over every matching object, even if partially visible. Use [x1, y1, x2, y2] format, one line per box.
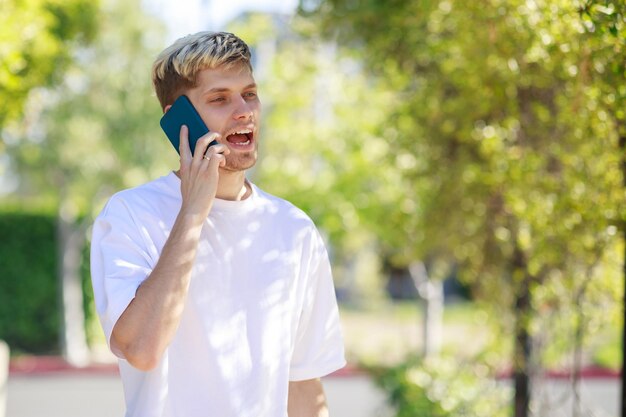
[160, 95, 218, 155]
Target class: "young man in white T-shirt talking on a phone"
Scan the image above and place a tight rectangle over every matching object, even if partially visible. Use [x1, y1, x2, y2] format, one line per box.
[91, 32, 345, 417]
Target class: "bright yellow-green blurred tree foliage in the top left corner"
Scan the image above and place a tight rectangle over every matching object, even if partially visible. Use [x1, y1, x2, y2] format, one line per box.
[0, 0, 98, 128]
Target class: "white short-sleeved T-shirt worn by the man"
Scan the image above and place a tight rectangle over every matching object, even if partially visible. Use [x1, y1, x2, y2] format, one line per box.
[91, 173, 345, 417]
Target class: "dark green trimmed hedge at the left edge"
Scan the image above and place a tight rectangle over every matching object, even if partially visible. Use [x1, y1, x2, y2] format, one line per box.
[0, 213, 59, 353]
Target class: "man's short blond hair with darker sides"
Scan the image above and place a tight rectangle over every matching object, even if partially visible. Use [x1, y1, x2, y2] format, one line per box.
[152, 32, 252, 108]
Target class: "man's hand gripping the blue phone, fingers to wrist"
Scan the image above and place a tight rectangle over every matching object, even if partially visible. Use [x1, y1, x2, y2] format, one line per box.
[179, 126, 230, 221]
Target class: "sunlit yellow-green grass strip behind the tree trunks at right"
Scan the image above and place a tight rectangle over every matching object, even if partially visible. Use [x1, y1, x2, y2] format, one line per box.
[340, 301, 622, 370]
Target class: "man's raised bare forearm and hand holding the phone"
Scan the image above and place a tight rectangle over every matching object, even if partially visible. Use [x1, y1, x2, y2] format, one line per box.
[111, 128, 228, 371]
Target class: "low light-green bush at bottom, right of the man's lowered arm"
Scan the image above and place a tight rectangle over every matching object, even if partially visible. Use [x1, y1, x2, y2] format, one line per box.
[369, 358, 510, 417]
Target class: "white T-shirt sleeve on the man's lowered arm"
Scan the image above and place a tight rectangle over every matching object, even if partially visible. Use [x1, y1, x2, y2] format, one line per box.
[289, 231, 346, 381]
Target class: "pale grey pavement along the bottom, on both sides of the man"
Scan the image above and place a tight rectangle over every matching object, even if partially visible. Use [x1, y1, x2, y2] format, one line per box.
[6, 367, 620, 417]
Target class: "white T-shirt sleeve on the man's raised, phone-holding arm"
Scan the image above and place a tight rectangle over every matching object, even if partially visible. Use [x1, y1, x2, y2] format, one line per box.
[91, 196, 153, 357]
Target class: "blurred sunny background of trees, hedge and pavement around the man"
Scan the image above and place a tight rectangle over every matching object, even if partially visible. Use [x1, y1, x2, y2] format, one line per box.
[0, 0, 626, 417]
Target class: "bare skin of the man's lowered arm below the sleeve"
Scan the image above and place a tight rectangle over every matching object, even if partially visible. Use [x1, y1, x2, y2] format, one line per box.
[287, 378, 328, 417]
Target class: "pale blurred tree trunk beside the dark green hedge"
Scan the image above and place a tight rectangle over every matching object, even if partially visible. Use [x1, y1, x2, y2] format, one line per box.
[57, 209, 89, 366]
